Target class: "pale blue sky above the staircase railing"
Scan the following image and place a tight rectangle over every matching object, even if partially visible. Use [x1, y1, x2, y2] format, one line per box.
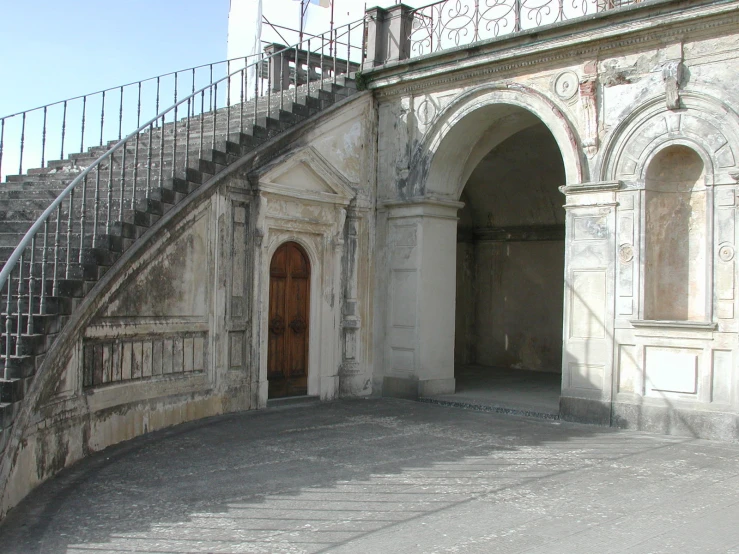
[0, 0, 414, 115]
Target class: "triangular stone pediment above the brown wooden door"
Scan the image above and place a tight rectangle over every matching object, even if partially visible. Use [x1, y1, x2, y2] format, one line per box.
[249, 146, 356, 205]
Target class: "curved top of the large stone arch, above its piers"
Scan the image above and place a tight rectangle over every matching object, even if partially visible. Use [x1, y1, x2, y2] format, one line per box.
[408, 85, 587, 200]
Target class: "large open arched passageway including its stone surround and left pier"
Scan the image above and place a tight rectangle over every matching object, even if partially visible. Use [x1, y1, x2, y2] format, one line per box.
[382, 94, 582, 406]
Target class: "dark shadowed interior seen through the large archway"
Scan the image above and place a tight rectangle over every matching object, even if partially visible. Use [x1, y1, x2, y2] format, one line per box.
[455, 123, 565, 414]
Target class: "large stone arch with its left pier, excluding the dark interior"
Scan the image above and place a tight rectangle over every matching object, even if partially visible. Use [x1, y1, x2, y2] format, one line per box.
[381, 85, 588, 396]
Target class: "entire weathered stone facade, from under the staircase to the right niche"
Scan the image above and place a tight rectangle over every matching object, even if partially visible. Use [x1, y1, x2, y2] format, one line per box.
[0, 1, 739, 510]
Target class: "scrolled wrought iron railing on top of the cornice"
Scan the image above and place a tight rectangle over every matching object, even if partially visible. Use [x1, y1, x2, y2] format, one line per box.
[410, 0, 640, 57]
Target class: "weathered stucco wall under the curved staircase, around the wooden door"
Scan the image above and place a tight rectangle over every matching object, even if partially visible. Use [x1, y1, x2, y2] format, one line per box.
[0, 93, 375, 514]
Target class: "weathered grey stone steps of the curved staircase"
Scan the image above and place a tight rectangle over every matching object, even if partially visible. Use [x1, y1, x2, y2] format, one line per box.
[0, 76, 357, 452]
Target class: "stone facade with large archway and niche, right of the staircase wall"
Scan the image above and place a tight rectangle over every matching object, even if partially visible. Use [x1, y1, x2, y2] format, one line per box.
[370, 2, 739, 440]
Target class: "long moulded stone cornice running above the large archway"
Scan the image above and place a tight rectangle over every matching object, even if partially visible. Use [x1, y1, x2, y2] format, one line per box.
[367, 0, 739, 98]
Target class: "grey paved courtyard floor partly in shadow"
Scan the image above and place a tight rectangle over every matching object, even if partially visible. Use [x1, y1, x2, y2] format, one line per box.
[0, 400, 739, 554]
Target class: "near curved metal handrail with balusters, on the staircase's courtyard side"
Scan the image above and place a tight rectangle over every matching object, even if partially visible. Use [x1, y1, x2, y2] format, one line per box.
[0, 18, 364, 370]
